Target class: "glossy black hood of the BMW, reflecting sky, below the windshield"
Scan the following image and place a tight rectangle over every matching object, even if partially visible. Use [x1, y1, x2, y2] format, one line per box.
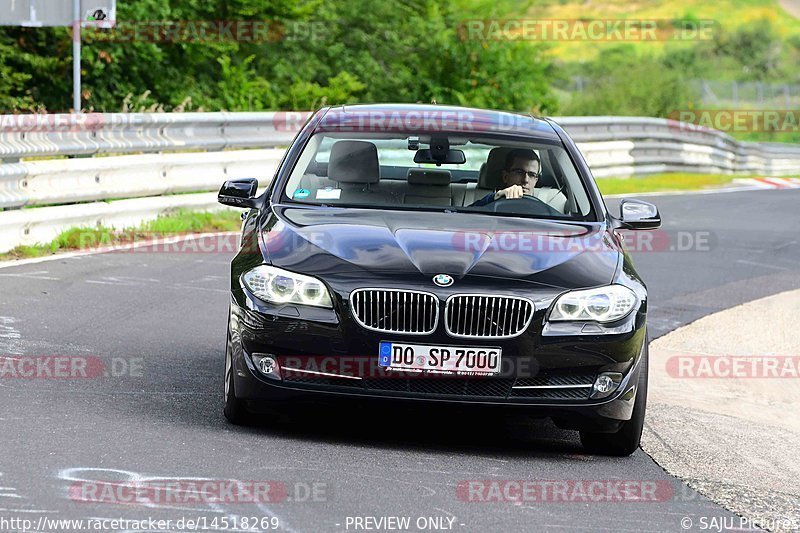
[262, 206, 621, 288]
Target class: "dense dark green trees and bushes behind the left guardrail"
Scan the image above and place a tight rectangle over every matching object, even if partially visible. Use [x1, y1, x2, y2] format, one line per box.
[0, 0, 556, 112]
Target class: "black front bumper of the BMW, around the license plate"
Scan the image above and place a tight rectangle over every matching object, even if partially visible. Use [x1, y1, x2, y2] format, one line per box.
[229, 284, 646, 431]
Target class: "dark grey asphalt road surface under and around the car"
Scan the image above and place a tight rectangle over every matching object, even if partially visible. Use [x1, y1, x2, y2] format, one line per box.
[0, 190, 800, 532]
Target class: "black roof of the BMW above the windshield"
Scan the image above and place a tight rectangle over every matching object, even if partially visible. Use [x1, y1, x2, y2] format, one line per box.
[316, 104, 559, 140]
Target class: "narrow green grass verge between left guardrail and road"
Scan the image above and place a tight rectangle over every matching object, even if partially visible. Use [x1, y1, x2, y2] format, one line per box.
[0, 209, 242, 261]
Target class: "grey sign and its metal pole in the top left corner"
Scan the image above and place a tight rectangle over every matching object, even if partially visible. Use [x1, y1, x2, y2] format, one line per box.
[0, 0, 117, 113]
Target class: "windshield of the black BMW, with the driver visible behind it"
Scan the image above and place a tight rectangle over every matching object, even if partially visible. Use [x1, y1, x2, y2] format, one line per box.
[284, 132, 591, 220]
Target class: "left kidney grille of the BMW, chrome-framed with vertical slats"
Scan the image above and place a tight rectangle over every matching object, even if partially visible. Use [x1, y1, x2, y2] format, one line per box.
[350, 289, 439, 335]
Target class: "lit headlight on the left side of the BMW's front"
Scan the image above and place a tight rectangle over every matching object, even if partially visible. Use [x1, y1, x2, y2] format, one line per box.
[242, 265, 333, 308]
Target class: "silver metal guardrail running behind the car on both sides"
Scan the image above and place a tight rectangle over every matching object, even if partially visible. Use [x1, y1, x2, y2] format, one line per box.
[0, 112, 800, 252]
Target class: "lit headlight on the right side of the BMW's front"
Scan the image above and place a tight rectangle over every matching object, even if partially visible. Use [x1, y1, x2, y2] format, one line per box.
[549, 285, 637, 322]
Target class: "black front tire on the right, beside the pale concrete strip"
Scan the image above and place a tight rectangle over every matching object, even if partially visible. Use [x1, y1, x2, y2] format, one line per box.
[581, 338, 650, 457]
